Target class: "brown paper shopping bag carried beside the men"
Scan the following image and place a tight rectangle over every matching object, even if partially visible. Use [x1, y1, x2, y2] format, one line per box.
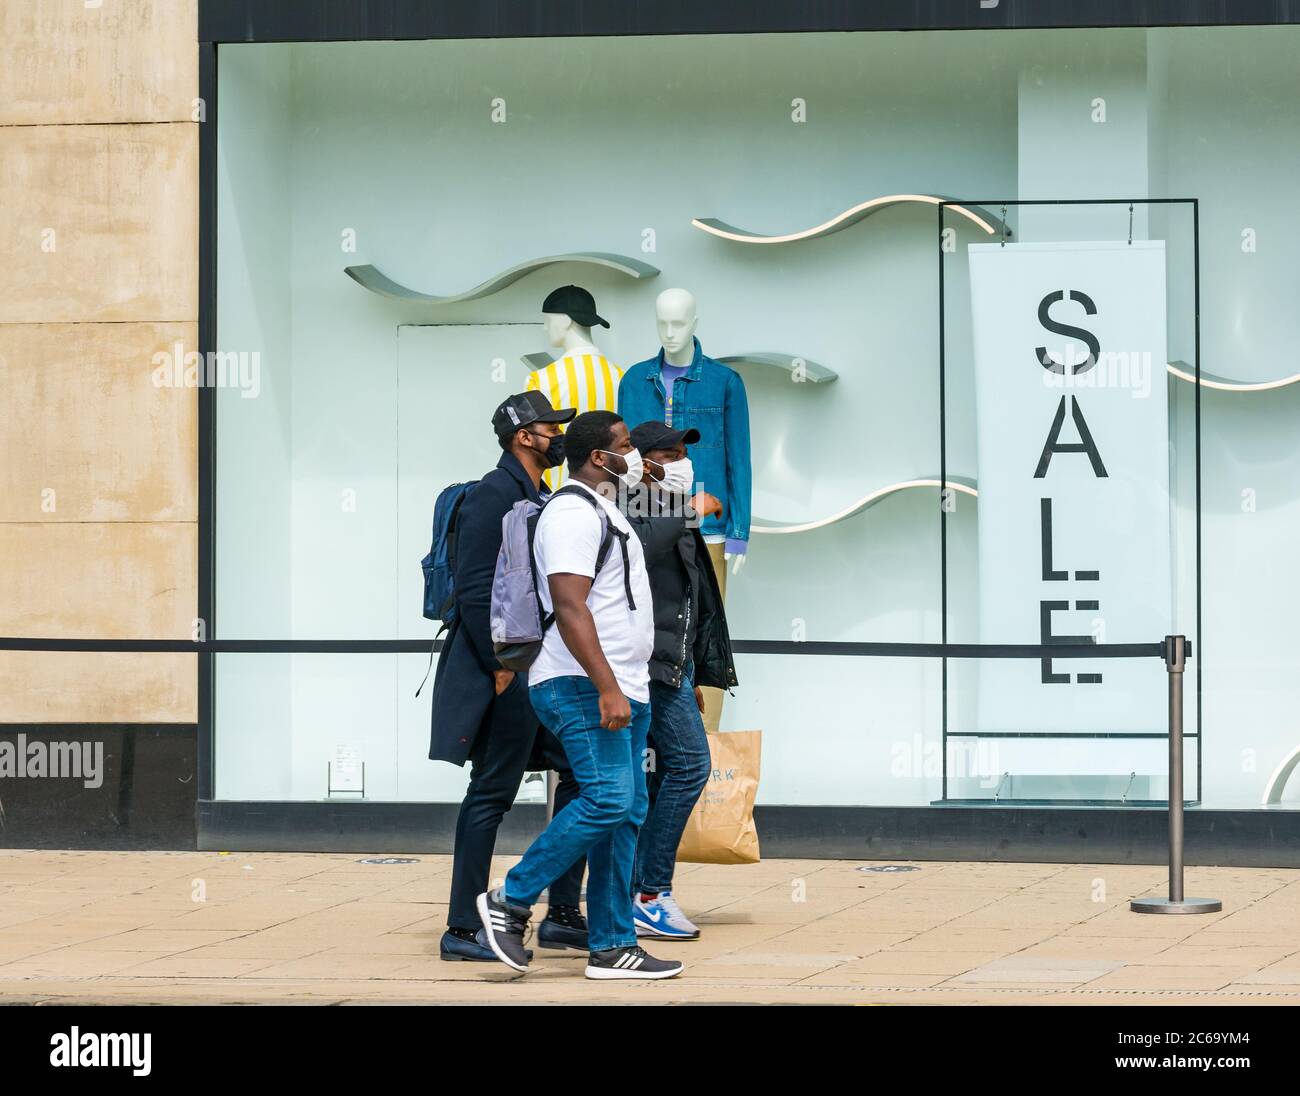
[677, 731, 763, 863]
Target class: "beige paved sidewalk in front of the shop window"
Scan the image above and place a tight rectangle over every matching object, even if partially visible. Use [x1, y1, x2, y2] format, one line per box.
[0, 850, 1300, 1005]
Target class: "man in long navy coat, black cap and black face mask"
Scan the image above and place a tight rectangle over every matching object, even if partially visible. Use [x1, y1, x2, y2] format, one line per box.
[429, 391, 586, 962]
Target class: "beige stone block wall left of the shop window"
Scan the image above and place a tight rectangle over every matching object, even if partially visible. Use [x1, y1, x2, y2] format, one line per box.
[0, 0, 199, 723]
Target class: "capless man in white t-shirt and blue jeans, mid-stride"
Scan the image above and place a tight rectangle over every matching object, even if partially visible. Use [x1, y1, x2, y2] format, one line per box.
[478, 411, 683, 979]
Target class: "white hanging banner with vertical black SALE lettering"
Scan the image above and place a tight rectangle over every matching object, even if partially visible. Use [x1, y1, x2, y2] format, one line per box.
[970, 241, 1174, 743]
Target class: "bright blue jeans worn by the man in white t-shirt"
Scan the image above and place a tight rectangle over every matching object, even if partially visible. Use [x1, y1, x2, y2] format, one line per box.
[504, 677, 650, 952]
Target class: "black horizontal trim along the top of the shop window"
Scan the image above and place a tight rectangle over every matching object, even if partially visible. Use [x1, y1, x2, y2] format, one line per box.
[199, 0, 1300, 42]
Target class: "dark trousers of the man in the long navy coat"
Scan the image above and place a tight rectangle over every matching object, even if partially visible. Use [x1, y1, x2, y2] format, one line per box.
[447, 677, 586, 930]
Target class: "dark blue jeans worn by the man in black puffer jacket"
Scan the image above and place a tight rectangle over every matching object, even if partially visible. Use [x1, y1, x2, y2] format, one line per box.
[632, 667, 712, 893]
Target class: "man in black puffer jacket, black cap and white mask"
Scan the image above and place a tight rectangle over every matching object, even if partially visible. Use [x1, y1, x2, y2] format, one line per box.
[621, 421, 737, 940]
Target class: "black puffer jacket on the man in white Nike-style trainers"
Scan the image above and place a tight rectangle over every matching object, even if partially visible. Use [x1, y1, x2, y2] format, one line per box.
[624, 486, 738, 689]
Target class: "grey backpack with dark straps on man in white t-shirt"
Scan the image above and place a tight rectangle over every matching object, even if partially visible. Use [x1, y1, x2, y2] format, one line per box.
[489, 484, 637, 673]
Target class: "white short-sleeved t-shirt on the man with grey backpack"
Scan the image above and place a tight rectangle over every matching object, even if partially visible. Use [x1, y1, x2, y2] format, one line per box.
[528, 480, 654, 702]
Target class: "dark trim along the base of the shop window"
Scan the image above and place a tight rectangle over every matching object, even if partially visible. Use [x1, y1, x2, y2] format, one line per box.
[199, 800, 1300, 871]
